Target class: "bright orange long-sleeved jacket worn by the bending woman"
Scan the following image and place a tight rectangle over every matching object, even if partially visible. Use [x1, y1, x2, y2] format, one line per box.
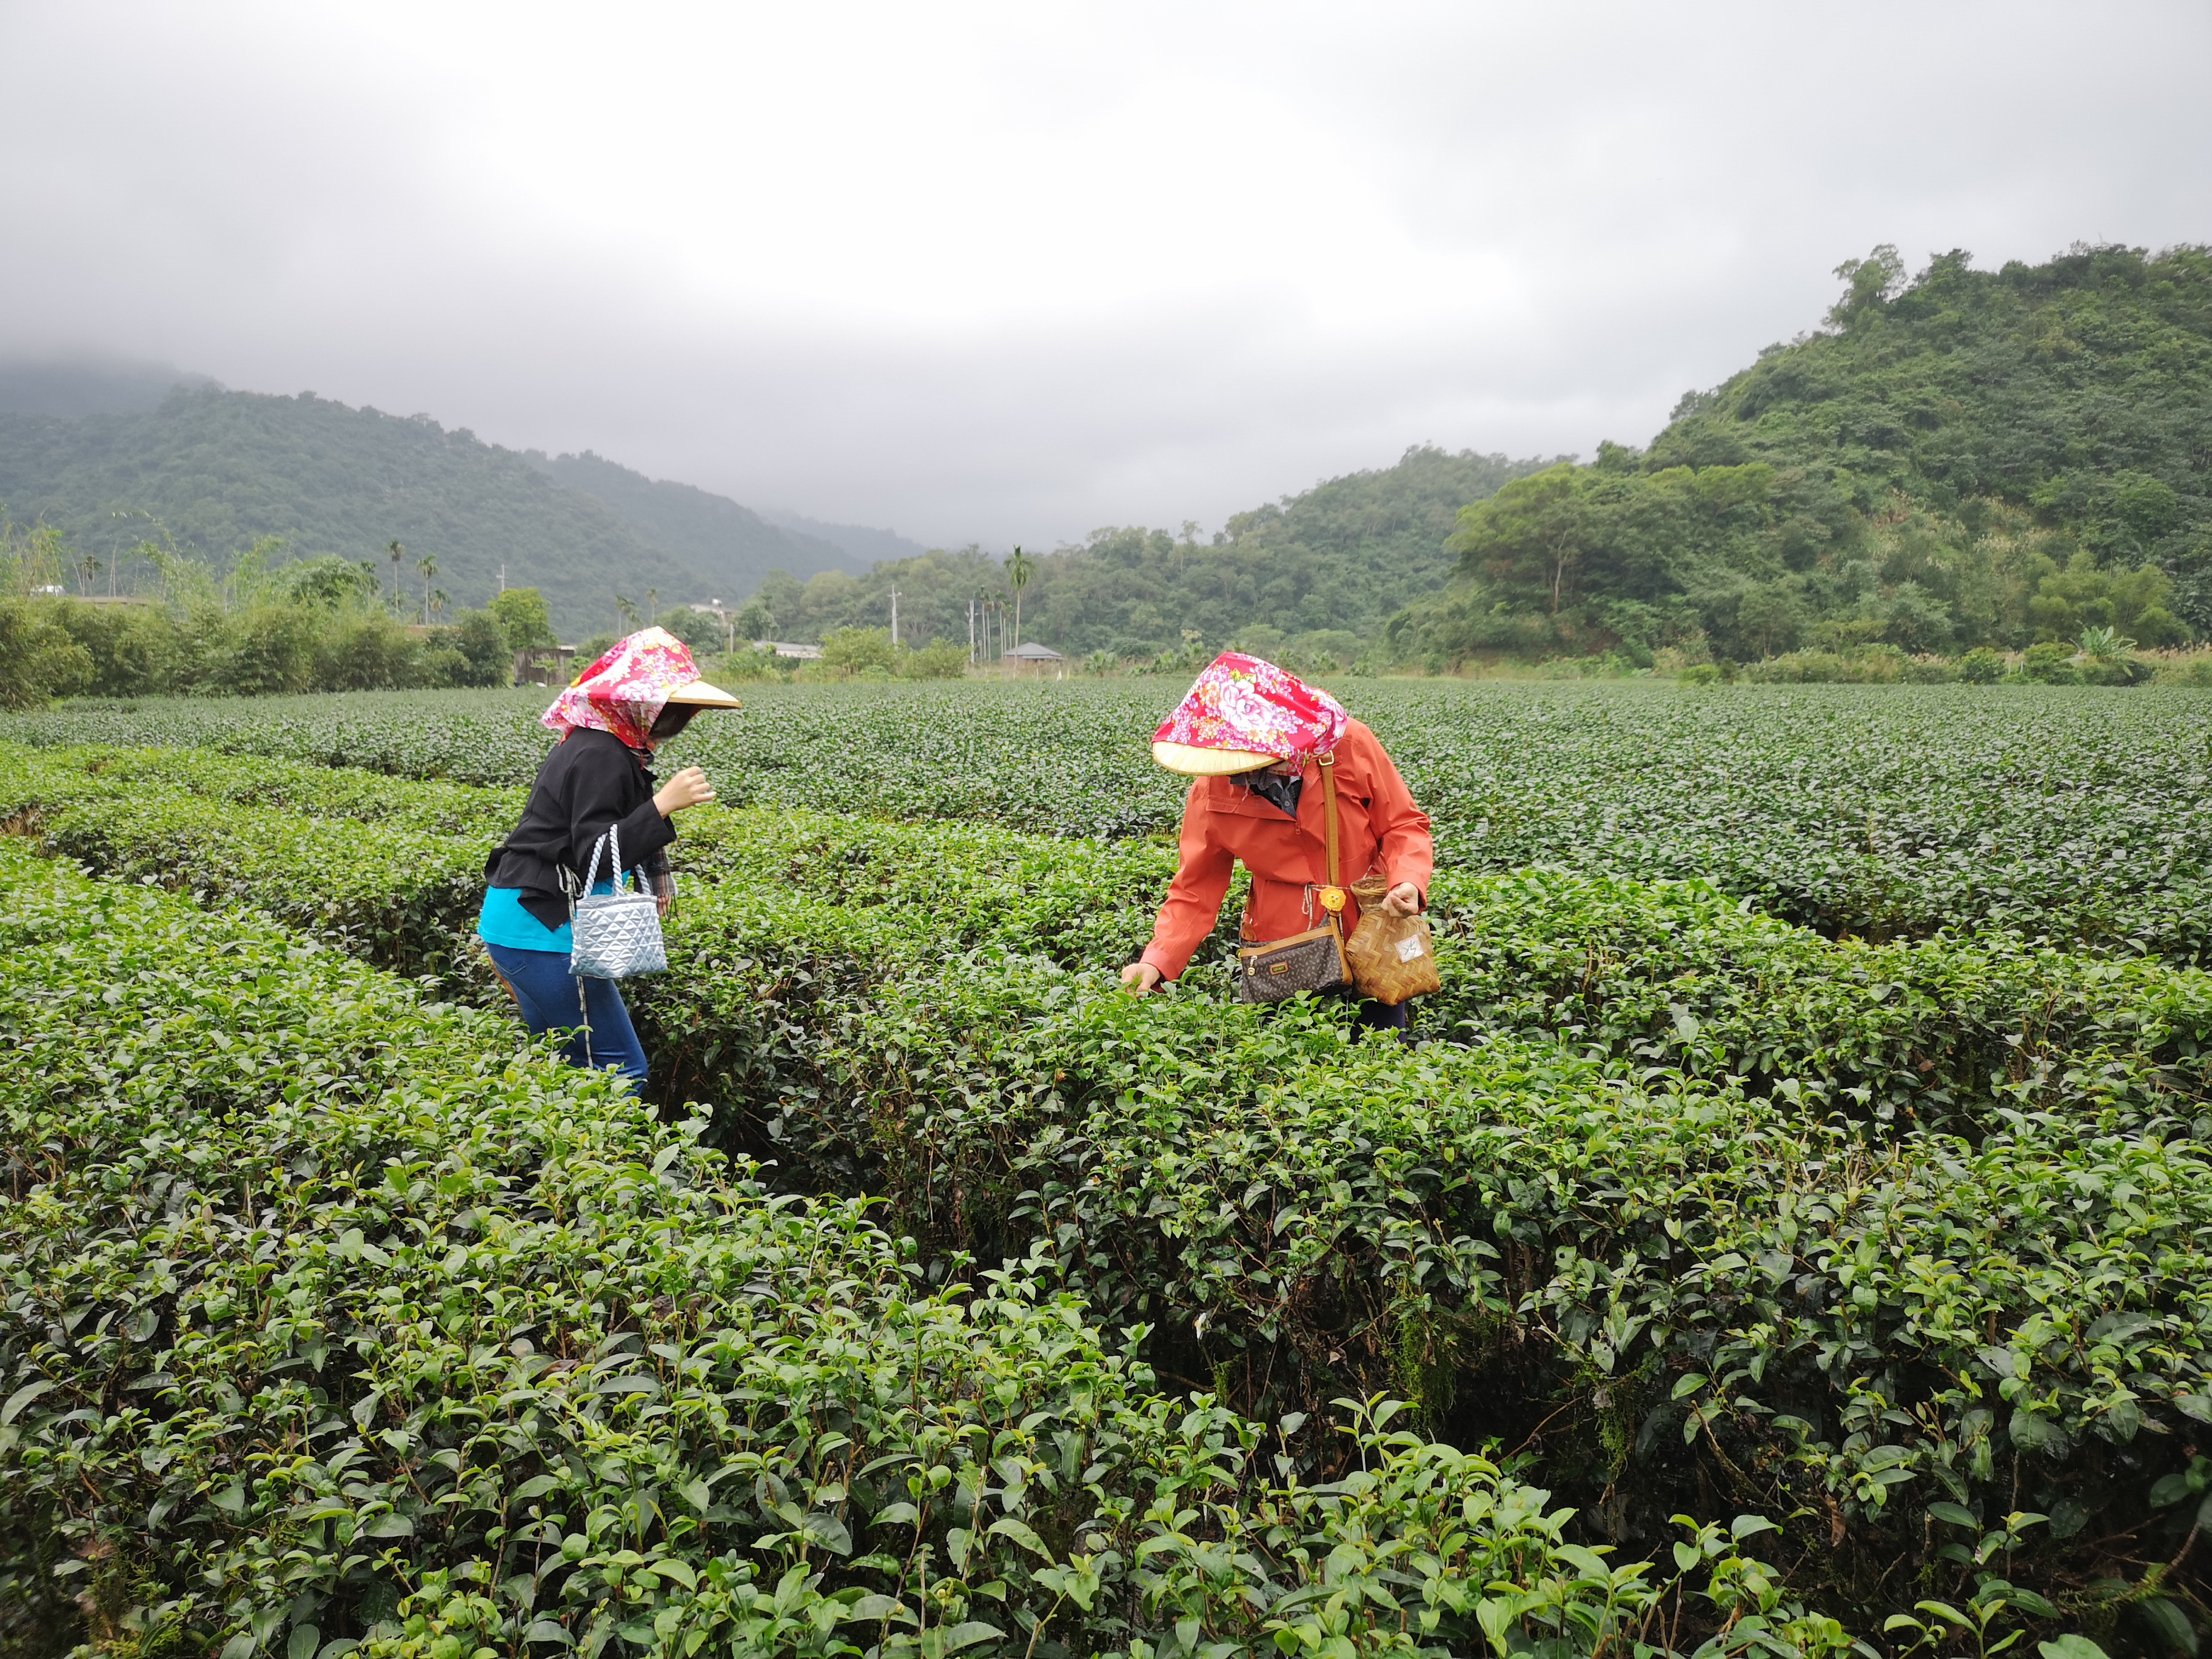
[1137, 721, 1436, 980]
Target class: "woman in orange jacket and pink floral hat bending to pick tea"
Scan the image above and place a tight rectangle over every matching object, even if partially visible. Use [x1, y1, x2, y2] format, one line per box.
[1122, 651, 1436, 1027]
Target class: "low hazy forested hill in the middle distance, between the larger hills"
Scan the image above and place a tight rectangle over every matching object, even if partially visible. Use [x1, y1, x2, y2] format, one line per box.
[739, 447, 1544, 662]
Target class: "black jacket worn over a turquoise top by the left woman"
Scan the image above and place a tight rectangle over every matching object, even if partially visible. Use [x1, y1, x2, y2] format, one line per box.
[484, 726, 677, 927]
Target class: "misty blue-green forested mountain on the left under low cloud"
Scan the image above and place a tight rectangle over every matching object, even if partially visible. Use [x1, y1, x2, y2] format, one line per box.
[0, 385, 840, 637]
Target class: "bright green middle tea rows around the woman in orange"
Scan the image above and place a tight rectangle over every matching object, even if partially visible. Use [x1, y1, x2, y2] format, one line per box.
[0, 750, 2212, 1641]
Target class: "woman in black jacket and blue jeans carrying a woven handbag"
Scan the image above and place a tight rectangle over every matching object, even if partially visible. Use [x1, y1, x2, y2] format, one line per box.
[475, 628, 739, 1086]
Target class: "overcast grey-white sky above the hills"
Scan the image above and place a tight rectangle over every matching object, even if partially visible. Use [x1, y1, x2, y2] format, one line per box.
[0, 0, 2212, 546]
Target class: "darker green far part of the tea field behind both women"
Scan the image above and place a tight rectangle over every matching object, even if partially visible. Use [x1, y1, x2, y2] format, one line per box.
[0, 682, 2212, 962]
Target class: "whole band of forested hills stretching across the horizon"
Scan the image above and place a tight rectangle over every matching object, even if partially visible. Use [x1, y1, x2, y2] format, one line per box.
[17, 248, 2212, 666]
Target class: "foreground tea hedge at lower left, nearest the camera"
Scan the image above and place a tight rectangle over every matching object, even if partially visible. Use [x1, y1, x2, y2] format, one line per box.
[0, 850, 1831, 1659]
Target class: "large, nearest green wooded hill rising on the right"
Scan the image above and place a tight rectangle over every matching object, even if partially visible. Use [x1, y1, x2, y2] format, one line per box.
[1392, 248, 2212, 659]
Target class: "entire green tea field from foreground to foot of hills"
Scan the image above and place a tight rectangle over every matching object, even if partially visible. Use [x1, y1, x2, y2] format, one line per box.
[0, 679, 2212, 1659]
